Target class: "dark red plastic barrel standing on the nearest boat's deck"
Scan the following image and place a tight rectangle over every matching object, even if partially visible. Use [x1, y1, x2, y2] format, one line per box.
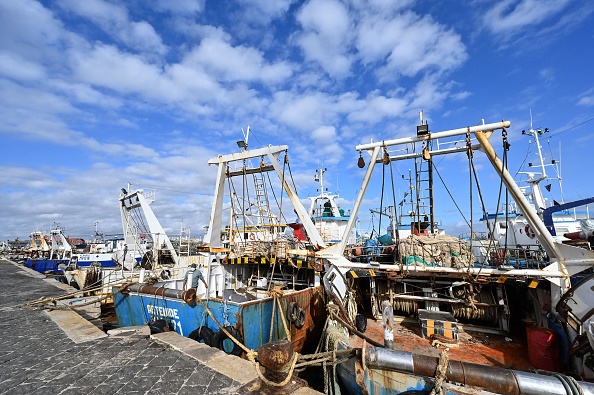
[526, 326, 561, 372]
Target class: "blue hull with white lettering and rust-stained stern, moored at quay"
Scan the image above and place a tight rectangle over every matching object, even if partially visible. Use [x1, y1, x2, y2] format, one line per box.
[114, 286, 326, 352]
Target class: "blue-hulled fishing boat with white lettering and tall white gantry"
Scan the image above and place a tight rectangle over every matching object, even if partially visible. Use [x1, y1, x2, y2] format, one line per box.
[114, 134, 326, 356]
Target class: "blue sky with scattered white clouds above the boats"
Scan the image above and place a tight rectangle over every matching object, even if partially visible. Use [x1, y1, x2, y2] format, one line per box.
[0, 0, 594, 240]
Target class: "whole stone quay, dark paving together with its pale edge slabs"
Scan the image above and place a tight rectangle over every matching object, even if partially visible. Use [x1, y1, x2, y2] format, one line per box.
[0, 260, 319, 395]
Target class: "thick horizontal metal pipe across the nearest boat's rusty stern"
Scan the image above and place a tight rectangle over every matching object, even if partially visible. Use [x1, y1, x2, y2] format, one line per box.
[364, 346, 594, 395]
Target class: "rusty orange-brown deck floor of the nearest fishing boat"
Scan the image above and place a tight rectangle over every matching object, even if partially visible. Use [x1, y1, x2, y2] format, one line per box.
[350, 316, 534, 370]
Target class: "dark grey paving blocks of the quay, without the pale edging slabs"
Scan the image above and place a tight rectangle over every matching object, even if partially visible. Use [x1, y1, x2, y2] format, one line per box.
[0, 259, 320, 395]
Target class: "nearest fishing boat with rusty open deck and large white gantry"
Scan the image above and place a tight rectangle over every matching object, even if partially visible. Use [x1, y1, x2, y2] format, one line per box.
[317, 117, 594, 394]
